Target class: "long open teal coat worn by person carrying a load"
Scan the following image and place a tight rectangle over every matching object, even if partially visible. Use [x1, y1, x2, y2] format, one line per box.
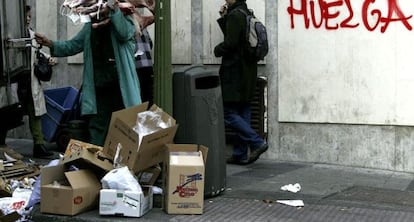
[51, 9, 141, 115]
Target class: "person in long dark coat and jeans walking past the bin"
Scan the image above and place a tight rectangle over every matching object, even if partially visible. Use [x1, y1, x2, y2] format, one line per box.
[214, 0, 268, 164]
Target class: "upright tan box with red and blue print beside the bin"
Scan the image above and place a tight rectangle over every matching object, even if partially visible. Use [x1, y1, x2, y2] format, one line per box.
[164, 144, 207, 214]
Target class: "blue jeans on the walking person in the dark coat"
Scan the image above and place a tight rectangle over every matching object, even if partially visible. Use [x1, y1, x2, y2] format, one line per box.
[223, 103, 265, 160]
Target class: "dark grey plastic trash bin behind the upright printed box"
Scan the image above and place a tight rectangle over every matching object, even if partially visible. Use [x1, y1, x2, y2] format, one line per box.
[173, 66, 226, 197]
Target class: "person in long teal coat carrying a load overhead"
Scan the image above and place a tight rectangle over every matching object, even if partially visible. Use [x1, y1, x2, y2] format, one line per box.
[35, 0, 141, 146]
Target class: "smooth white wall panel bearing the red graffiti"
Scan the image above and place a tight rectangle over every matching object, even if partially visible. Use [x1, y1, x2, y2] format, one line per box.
[278, 0, 414, 125]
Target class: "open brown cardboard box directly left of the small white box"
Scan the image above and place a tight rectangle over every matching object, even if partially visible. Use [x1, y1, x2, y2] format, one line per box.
[40, 165, 101, 215]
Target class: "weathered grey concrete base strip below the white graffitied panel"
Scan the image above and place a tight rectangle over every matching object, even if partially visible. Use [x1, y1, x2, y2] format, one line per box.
[269, 123, 414, 172]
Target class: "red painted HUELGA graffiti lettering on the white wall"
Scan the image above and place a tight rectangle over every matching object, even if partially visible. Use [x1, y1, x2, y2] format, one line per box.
[287, 0, 412, 33]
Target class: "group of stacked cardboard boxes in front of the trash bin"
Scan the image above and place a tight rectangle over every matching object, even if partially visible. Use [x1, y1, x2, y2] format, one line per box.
[40, 103, 207, 217]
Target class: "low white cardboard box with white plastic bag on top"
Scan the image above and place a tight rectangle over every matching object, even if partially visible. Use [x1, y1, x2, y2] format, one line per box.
[99, 187, 153, 217]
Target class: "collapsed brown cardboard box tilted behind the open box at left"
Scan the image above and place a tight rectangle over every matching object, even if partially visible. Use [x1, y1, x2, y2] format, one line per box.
[60, 139, 113, 177]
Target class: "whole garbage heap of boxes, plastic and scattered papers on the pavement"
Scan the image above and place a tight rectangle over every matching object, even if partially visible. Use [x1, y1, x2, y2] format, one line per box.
[0, 103, 207, 221]
